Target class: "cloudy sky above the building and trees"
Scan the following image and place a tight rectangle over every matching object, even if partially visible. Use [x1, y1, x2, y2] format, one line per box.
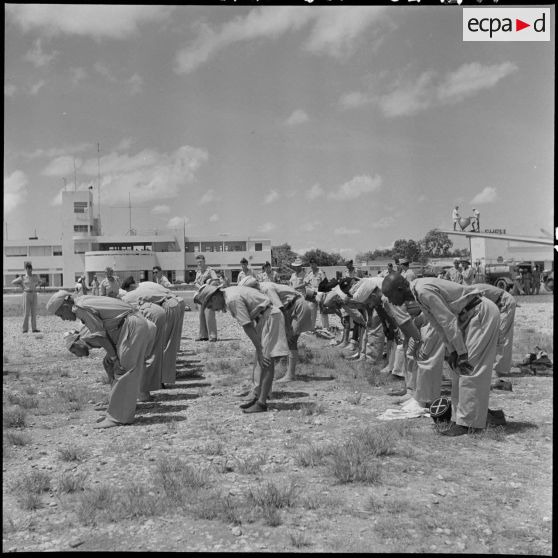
[4, 4, 555, 258]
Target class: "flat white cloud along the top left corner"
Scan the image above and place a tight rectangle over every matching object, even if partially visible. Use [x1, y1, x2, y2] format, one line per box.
[5, 4, 173, 40]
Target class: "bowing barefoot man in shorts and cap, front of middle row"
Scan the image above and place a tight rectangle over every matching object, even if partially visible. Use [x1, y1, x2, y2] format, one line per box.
[194, 285, 289, 413]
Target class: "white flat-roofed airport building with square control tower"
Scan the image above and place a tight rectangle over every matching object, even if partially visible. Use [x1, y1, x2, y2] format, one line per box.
[3, 190, 271, 289]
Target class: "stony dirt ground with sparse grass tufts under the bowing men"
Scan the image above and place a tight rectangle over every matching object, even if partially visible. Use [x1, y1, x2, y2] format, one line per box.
[3, 295, 553, 556]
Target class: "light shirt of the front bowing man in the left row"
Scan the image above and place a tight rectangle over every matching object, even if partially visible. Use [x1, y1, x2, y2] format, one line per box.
[72, 295, 136, 345]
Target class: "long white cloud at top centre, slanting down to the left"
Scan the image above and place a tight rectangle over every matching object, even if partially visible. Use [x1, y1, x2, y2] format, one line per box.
[175, 6, 390, 74]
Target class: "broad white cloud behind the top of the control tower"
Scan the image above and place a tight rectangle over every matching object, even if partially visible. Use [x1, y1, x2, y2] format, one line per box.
[42, 145, 208, 203]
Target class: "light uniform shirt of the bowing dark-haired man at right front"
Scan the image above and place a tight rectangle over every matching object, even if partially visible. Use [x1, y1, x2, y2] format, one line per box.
[411, 277, 482, 354]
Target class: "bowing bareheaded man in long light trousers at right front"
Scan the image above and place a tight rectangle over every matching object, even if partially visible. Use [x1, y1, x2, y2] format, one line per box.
[382, 274, 500, 436]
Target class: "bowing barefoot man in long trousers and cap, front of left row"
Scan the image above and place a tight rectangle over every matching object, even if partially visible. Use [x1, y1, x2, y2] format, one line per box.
[46, 290, 157, 428]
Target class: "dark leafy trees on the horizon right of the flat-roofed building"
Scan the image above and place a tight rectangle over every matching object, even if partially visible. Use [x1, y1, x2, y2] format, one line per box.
[271, 229, 469, 271]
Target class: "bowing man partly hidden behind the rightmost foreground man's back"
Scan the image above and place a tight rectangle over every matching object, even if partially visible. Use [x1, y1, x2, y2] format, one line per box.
[466, 283, 517, 377]
